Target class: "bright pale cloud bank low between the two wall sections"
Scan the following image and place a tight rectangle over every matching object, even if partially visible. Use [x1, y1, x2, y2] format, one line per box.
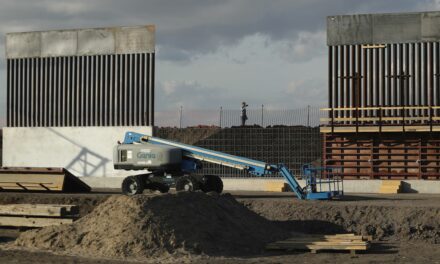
[157, 32, 327, 110]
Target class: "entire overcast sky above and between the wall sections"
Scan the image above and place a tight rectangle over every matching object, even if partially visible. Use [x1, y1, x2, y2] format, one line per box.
[0, 0, 440, 125]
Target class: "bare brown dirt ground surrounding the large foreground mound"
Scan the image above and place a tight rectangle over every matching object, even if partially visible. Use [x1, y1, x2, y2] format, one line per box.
[0, 190, 440, 263]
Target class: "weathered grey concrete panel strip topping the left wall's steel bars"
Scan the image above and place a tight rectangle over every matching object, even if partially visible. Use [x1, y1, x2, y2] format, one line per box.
[6, 25, 155, 59]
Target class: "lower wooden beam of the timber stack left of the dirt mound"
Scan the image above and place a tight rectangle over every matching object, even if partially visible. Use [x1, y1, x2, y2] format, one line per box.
[0, 216, 73, 227]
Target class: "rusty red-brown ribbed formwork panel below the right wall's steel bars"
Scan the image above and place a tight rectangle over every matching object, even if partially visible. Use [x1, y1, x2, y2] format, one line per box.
[323, 133, 440, 179]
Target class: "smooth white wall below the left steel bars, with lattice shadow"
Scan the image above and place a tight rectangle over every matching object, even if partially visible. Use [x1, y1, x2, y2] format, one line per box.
[3, 126, 153, 177]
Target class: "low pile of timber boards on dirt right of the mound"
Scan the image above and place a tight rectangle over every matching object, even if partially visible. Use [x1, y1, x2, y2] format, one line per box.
[266, 234, 372, 255]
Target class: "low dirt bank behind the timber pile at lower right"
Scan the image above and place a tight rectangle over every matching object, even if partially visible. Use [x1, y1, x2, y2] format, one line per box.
[243, 199, 440, 244]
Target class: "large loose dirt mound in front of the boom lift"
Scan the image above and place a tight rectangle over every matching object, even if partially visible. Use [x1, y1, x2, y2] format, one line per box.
[16, 192, 285, 258]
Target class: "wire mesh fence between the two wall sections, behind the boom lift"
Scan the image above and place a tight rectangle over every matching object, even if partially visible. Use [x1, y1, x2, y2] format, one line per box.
[154, 107, 322, 177]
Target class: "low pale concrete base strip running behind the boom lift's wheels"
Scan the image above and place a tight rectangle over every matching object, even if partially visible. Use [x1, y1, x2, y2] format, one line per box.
[81, 177, 440, 193]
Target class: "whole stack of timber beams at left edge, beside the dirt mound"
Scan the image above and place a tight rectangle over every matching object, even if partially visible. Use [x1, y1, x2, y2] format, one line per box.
[0, 204, 79, 227]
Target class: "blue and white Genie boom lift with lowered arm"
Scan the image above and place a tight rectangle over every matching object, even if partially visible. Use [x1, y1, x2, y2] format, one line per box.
[113, 132, 343, 200]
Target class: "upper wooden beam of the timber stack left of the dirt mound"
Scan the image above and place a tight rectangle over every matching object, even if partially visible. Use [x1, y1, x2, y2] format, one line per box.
[0, 204, 79, 217]
